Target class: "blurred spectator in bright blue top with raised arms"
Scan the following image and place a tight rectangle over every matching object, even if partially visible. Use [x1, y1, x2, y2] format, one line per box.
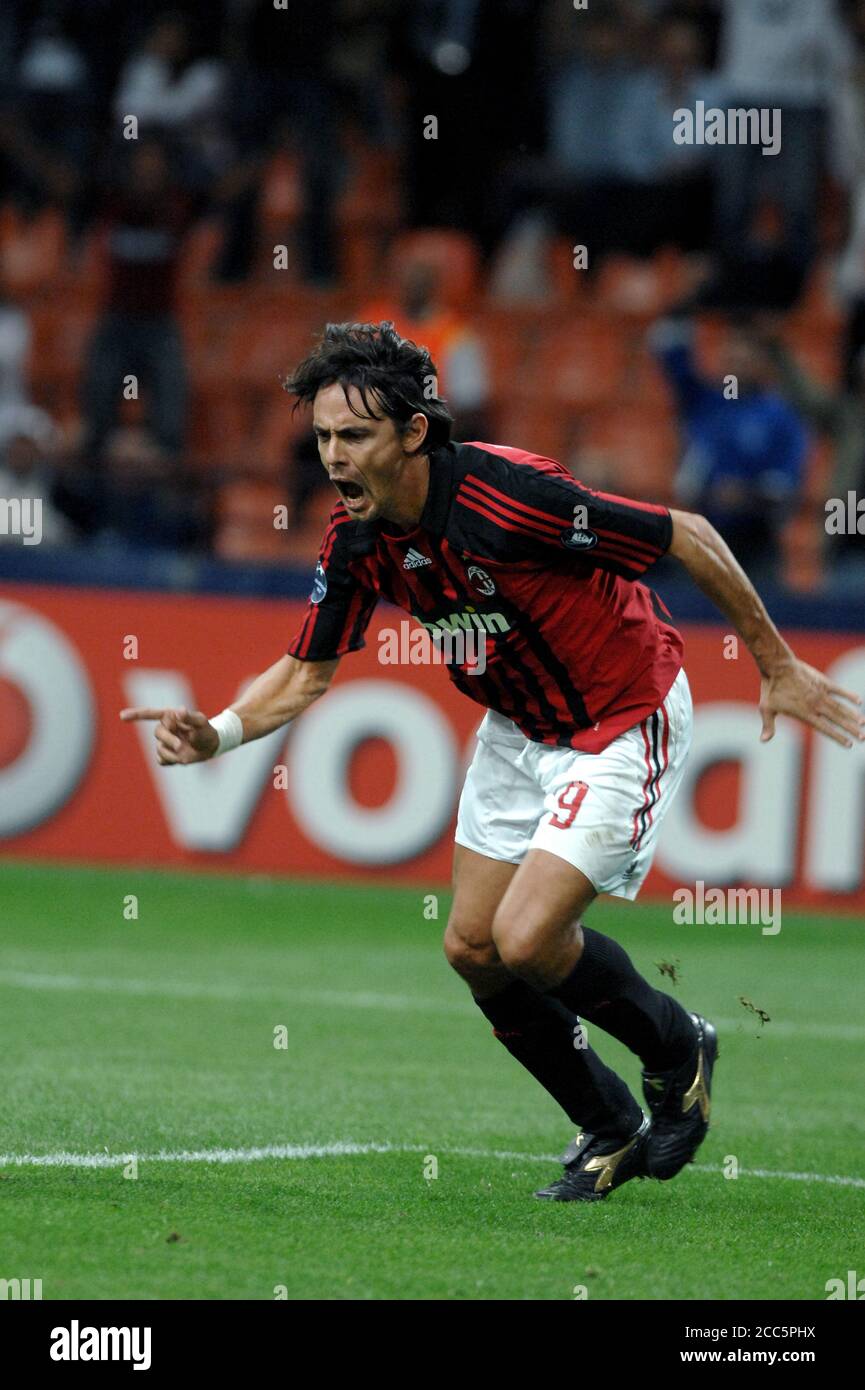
[649, 318, 808, 577]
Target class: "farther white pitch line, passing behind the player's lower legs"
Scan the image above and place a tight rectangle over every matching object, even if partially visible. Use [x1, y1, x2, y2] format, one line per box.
[0, 970, 865, 1043]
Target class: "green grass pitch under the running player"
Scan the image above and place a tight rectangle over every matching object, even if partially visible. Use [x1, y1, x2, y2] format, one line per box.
[0, 863, 865, 1300]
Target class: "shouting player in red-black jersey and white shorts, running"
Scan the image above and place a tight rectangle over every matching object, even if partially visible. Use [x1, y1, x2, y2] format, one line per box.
[121, 322, 865, 1201]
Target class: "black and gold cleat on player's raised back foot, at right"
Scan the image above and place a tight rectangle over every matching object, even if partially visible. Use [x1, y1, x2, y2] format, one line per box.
[642, 1013, 718, 1182]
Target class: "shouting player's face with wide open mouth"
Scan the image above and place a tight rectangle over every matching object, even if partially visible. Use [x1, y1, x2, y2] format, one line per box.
[313, 382, 426, 521]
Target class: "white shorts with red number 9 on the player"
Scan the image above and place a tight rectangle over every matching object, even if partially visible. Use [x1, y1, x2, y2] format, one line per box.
[455, 670, 693, 898]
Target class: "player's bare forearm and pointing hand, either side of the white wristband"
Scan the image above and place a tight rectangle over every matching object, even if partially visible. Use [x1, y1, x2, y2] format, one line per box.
[120, 656, 339, 767]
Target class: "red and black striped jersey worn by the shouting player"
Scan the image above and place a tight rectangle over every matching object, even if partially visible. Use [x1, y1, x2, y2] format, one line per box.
[288, 443, 683, 752]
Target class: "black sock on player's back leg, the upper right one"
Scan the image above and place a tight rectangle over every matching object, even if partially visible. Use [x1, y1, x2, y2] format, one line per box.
[549, 927, 694, 1072]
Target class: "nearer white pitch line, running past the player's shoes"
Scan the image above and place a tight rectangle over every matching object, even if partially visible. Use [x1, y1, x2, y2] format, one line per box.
[0, 1140, 865, 1187]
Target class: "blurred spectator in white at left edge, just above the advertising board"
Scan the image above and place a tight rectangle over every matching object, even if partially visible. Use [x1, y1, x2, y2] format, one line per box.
[0, 404, 72, 545]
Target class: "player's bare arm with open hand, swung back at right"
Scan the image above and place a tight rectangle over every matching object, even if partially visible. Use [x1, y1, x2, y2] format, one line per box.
[669, 512, 865, 748]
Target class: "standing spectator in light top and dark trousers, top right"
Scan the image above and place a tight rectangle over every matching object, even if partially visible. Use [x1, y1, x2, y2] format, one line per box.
[705, 0, 850, 307]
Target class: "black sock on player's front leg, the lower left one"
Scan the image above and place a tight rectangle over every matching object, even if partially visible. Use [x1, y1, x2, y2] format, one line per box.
[474, 980, 641, 1137]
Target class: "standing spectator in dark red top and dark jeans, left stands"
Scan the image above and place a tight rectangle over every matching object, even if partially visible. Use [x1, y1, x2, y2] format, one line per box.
[82, 138, 195, 460]
